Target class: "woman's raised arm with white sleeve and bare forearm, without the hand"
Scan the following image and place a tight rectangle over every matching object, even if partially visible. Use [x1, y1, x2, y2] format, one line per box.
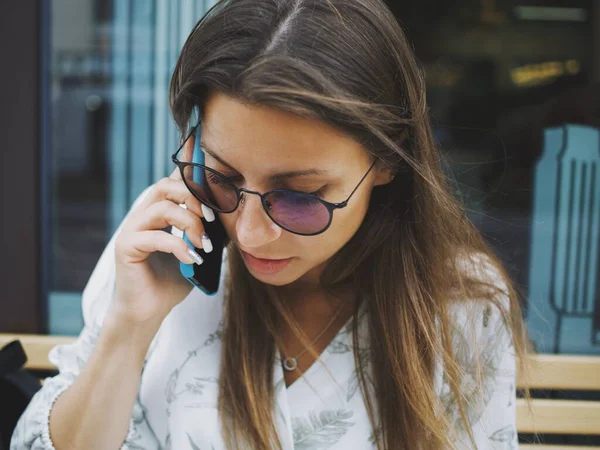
[10, 189, 160, 450]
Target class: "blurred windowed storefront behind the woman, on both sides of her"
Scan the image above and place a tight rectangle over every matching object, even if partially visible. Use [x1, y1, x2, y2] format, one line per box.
[0, 0, 600, 360]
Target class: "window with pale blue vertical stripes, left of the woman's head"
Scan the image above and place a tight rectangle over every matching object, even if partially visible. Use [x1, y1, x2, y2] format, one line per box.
[42, 0, 218, 334]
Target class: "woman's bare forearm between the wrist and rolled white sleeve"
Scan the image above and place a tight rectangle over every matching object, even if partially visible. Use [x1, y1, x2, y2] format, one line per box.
[50, 315, 157, 450]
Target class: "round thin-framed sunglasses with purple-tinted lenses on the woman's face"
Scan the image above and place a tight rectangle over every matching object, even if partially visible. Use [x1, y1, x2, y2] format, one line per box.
[171, 124, 375, 236]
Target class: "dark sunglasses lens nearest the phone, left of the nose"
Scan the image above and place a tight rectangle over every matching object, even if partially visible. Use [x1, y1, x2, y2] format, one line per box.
[183, 165, 238, 212]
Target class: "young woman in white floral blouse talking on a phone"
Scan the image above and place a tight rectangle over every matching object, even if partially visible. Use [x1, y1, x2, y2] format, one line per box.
[12, 0, 522, 450]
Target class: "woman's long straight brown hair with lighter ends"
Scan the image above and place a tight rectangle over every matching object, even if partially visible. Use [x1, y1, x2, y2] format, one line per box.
[170, 0, 523, 449]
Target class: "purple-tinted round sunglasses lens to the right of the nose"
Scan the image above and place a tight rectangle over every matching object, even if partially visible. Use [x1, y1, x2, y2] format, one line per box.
[266, 191, 331, 234]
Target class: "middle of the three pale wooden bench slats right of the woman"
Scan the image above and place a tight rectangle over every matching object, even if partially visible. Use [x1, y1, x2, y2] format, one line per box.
[517, 399, 600, 435]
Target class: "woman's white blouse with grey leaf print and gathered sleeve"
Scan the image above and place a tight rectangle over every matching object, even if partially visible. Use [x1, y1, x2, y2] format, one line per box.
[10, 185, 518, 450]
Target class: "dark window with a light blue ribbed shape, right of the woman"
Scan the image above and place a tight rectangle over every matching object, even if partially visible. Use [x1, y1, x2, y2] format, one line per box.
[389, 0, 600, 354]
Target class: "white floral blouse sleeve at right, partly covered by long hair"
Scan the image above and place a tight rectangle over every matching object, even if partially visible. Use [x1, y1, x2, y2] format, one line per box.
[441, 253, 519, 450]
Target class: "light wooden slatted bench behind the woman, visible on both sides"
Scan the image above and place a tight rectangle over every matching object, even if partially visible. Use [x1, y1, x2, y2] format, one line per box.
[0, 334, 600, 444]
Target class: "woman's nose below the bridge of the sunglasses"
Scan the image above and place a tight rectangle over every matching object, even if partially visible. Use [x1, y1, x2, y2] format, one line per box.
[235, 192, 281, 248]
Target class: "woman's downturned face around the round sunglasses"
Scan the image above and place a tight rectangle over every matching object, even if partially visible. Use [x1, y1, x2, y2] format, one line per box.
[186, 93, 390, 286]
